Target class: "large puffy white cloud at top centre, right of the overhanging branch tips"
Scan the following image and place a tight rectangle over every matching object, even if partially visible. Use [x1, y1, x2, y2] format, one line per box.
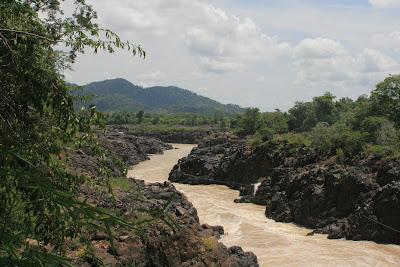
[184, 3, 290, 73]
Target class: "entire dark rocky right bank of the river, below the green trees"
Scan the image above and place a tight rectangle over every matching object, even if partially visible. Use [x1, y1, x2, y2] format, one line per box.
[169, 138, 400, 244]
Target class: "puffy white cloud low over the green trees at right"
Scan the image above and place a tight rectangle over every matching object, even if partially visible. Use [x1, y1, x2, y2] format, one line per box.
[292, 38, 400, 94]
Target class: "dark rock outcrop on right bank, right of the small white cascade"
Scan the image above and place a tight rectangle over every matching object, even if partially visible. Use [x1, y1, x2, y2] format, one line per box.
[253, 157, 400, 244]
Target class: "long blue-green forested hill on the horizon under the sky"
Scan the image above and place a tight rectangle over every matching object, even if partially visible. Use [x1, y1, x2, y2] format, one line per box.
[75, 79, 243, 114]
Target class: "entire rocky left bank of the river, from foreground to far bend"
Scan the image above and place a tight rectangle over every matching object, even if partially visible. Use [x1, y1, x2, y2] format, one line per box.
[68, 129, 258, 267]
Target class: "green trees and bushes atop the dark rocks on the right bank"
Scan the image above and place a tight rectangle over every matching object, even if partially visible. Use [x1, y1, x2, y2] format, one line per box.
[230, 75, 400, 158]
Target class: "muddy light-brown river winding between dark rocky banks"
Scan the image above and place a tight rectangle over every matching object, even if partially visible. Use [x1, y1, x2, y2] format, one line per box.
[128, 144, 400, 266]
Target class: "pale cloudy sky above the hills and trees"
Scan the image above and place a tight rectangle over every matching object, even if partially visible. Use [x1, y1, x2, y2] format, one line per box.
[66, 0, 400, 111]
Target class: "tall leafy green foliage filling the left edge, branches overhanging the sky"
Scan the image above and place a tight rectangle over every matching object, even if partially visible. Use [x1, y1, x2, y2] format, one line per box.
[0, 0, 144, 266]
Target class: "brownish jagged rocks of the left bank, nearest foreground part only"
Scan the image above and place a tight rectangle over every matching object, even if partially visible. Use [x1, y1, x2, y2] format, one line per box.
[70, 179, 258, 267]
